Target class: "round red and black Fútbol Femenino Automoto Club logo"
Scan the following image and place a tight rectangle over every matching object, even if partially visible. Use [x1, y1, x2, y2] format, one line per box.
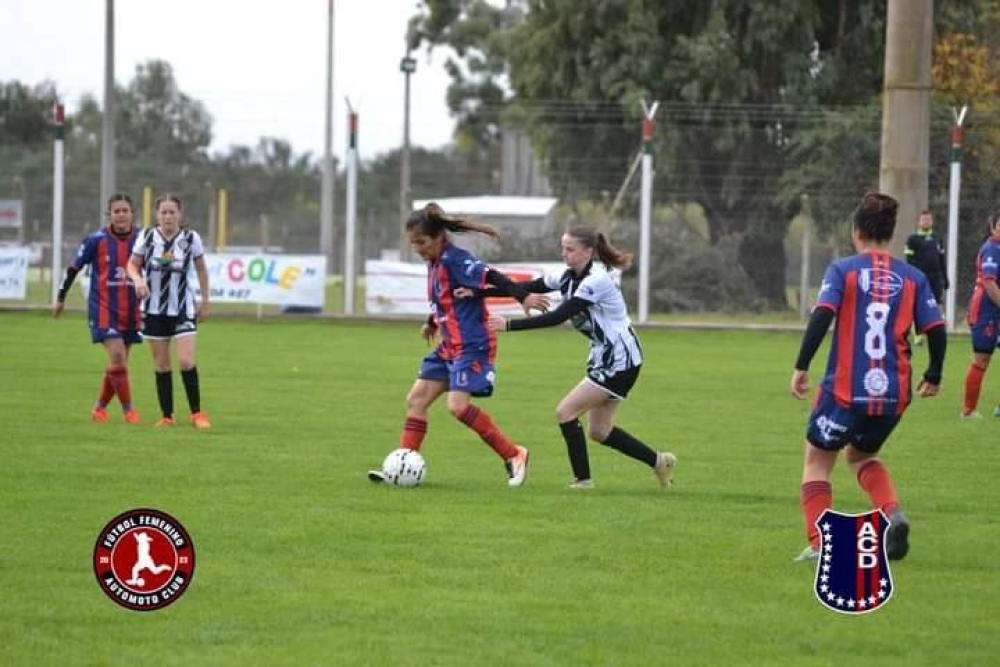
[94, 509, 195, 611]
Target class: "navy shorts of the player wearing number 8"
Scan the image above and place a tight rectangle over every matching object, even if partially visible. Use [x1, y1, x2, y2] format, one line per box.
[806, 391, 900, 454]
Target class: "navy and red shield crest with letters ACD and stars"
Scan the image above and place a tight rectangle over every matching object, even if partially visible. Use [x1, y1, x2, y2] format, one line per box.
[813, 509, 892, 614]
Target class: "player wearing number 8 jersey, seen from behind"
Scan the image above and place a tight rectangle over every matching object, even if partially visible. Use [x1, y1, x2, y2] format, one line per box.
[791, 192, 947, 561]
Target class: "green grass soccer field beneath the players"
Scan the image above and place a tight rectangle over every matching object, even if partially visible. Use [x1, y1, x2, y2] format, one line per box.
[0, 313, 1000, 667]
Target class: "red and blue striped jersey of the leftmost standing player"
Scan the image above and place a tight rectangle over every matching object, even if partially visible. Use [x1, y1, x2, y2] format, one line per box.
[73, 226, 142, 331]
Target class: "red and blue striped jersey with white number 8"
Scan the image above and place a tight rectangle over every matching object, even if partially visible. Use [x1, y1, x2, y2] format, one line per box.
[816, 252, 944, 415]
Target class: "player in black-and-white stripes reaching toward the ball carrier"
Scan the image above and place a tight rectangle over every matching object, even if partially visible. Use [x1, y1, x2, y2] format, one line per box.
[481, 228, 677, 489]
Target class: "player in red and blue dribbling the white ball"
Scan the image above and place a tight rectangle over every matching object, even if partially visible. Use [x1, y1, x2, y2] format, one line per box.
[368, 203, 548, 486]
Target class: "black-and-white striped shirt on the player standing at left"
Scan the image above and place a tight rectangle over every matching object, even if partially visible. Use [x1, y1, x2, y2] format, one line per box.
[132, 227, 205, 319]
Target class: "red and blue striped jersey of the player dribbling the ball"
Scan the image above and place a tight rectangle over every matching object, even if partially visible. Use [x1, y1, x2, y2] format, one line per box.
[427, 243, 497, 361]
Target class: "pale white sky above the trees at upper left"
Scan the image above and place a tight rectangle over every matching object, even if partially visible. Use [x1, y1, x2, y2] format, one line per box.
[0, 0, 454, 160]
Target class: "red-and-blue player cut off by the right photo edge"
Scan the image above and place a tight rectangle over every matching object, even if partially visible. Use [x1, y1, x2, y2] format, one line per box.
[961, 210, 1000, 419]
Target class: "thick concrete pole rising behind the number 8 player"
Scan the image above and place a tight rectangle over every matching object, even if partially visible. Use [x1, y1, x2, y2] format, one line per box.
[879, 0, 934, 256]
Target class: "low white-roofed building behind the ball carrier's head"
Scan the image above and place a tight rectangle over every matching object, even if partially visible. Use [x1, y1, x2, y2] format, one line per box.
[413, 195, 559, 253]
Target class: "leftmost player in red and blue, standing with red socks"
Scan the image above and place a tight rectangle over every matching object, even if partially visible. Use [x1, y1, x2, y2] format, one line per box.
[52, 194, 142, 424]
